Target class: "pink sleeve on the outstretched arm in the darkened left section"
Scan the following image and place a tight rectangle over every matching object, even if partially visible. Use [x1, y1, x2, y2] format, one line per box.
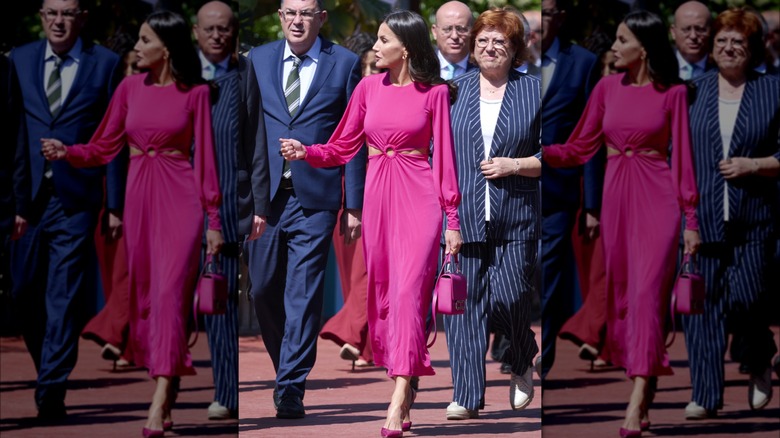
[65, 80, 129, 167]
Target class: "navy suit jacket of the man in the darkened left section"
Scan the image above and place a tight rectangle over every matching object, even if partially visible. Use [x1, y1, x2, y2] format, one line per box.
[11, 40, 127, 215]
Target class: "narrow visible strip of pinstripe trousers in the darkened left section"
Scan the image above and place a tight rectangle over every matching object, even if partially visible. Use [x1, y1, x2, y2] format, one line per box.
[203, 250, 239, 412]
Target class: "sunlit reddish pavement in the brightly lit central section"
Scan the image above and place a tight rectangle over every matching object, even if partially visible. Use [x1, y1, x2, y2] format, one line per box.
[239, 326, 541, 438]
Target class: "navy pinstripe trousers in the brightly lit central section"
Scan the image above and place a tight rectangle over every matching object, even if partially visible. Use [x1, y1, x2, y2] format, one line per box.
[444, 240, 539, 409]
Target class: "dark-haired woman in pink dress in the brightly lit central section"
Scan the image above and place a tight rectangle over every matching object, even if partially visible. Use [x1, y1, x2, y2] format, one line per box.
[280, 11, 462, 437]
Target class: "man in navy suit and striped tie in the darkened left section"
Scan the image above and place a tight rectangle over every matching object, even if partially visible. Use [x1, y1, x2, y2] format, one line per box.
[11, 0, 124, 420]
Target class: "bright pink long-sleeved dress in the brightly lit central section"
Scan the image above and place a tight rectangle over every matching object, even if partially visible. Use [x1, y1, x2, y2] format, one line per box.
[306, 74, 460, 376]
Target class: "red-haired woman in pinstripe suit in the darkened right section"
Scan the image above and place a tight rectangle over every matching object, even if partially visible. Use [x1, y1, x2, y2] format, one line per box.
[683, 9, 780, 419]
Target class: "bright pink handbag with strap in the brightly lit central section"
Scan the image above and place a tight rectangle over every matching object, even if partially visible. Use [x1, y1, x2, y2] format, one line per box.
[428, 254, 466, 348]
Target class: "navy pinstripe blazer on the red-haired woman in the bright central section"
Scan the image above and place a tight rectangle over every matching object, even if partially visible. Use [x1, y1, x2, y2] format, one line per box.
[451, 70, 541, 243]
